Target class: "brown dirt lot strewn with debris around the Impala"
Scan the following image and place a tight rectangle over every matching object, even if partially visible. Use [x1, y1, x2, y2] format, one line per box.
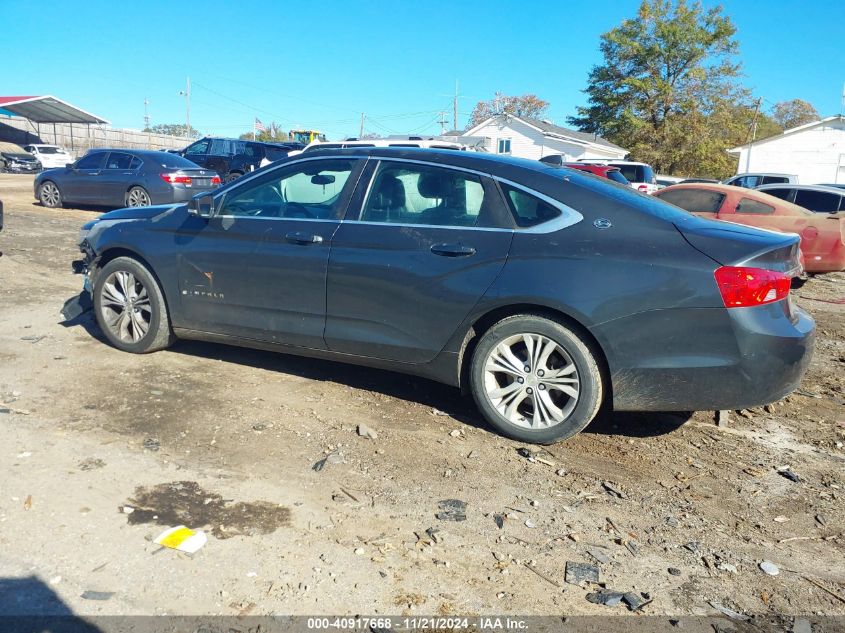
[0, 175, 845, 617]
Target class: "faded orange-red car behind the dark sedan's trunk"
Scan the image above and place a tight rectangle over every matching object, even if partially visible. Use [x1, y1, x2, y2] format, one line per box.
[654, 183, 845, 273]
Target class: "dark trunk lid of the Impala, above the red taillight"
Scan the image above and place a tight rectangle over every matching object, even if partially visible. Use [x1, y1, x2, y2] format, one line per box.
[674, 216, 803, 276]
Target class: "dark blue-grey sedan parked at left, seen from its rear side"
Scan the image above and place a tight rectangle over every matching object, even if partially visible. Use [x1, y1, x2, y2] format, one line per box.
[34, 149, 220, 207]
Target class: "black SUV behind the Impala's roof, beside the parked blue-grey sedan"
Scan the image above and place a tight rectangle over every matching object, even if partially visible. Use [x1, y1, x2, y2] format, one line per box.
[175, 137, 304, 182]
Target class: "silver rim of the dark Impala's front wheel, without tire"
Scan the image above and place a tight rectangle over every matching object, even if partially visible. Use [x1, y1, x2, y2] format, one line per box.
[100, 270, 152, 343]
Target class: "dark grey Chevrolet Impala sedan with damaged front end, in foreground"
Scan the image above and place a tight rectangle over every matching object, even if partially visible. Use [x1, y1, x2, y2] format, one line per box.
[80, 148, 815, 443]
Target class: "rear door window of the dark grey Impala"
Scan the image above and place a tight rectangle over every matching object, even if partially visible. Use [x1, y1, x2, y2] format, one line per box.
[361, 162, 485, 226]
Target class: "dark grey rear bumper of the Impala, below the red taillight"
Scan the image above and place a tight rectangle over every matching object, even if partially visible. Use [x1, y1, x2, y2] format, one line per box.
[602, 301, 815, 411]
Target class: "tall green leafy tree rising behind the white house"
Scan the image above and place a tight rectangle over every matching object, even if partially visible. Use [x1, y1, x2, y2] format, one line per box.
[569, 0, 753, 177]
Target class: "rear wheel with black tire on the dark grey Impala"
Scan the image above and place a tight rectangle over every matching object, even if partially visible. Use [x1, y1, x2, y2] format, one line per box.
[470, 314, 604, 444]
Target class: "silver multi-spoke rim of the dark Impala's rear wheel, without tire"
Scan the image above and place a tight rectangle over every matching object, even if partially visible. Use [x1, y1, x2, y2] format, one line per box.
[484, 333, 580, 429]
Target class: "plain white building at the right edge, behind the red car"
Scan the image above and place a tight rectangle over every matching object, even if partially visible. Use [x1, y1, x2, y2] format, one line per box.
[728, 115, 845, 185]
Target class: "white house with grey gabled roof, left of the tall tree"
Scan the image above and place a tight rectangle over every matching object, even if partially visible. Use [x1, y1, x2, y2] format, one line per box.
[458, 114, 628, 161]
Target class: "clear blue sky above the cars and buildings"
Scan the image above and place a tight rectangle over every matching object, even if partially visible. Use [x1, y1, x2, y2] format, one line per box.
[0, 0, 845, 138]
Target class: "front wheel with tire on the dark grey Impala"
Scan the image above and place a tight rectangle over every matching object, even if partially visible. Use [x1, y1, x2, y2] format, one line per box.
[94, 257, 176, 354]
